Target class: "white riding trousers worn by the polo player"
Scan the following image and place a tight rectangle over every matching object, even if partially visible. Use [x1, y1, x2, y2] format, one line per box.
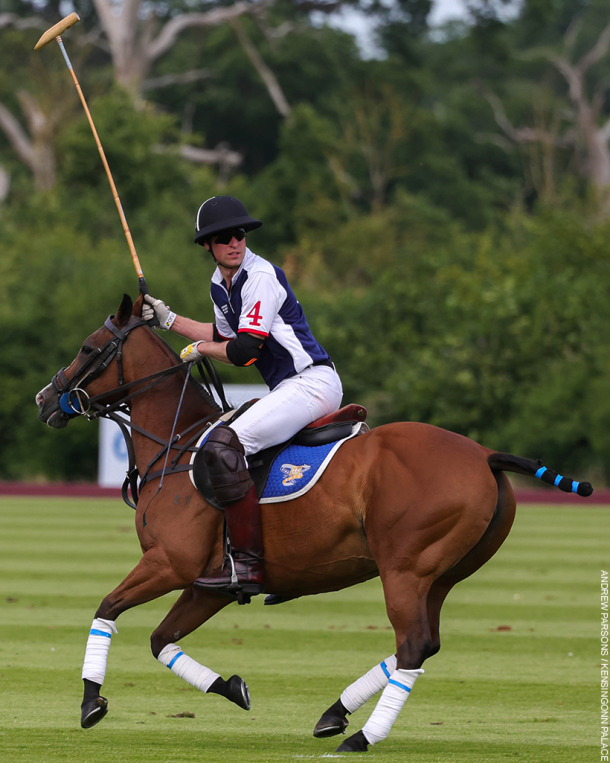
[231, 366, 343, 456]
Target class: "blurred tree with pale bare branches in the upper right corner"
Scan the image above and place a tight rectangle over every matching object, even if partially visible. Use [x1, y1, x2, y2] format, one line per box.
[481, 2, 610, 215]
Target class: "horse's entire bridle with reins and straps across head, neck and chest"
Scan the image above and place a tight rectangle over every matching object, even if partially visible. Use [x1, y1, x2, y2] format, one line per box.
[51, 315, 230, 509]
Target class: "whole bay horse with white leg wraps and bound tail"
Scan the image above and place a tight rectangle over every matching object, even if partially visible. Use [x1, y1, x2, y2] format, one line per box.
[36, 295, 592, 752]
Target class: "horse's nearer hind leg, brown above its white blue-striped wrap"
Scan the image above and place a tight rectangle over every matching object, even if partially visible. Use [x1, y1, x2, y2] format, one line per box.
[336, 571, 434, 752]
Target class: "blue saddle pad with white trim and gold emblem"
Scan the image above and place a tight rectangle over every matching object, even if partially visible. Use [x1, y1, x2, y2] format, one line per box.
[260, 422, 361, 503]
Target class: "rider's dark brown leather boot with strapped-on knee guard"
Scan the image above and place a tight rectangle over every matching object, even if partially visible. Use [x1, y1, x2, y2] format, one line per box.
[195, 426, 264, 603]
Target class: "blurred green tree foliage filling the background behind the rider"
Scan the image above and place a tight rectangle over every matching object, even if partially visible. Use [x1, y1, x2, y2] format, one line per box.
[0, 0, 610, 480]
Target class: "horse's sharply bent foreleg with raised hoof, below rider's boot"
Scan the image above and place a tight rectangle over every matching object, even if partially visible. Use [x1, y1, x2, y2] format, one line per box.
[150, 586, 250, 710]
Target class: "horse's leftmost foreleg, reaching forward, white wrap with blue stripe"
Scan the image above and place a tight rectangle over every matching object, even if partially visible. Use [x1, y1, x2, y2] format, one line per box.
[81, 548, 200, 729]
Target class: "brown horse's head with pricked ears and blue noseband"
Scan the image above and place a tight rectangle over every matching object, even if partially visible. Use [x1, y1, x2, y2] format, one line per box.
[36, 294, 146, 429]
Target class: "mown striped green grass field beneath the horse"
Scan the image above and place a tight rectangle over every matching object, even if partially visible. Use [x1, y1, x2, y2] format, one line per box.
[0, 498, 610, 763]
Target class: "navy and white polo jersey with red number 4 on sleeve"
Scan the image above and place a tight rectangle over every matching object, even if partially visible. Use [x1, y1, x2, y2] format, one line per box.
[210, 249, 330, 389]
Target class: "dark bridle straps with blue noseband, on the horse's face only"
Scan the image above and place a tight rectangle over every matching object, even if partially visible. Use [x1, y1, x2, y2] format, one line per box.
[51, 315, 146, 416]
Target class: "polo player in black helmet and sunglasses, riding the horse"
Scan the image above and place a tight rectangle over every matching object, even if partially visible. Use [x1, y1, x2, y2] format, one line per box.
[142, 196, 343, 594]
